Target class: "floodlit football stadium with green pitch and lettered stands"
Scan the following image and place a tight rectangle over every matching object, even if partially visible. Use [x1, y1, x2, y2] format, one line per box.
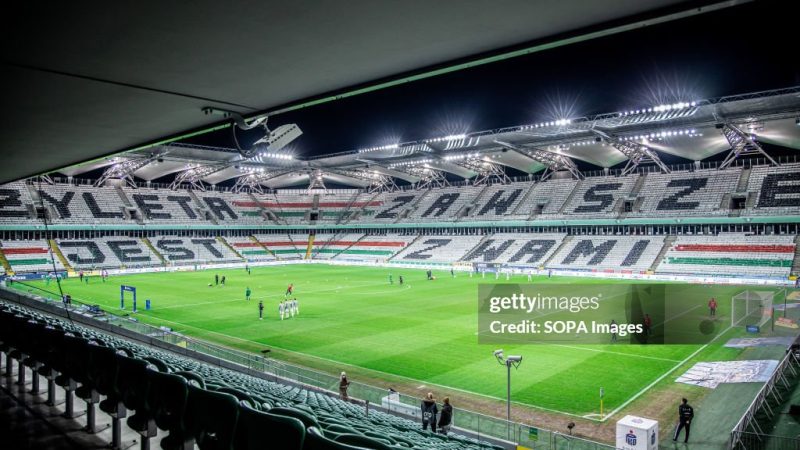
[0, 2, 800, 450]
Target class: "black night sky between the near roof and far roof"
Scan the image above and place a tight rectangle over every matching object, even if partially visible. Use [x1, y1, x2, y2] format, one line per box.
[187, 0, 800, 165]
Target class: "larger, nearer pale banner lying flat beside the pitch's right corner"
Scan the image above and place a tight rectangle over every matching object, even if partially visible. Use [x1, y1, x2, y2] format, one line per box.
[675, 359, 778, 389]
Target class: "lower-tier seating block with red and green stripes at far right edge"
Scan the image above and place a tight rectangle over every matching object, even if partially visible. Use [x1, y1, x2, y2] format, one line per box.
[657, 233, 795, 277]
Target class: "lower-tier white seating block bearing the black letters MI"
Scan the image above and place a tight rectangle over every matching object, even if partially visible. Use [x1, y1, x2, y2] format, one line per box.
[548, 236, 664, 273]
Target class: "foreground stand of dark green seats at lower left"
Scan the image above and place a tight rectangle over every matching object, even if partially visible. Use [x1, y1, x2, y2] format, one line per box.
[0, 303, 501, 450]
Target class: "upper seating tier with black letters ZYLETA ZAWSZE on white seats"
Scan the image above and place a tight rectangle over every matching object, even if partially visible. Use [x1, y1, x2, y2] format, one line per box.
[0, 164, 800, 225]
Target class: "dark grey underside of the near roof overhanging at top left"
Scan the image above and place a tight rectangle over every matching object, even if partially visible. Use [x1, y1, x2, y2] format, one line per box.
[0, 0, 741, 182]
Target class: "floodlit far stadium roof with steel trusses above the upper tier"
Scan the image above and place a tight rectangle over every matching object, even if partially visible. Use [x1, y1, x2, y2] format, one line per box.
[60, 87, 800, 188]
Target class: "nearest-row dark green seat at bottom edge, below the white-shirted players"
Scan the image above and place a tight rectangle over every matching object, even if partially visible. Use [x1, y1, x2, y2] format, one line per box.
[236, 405, 306, 450]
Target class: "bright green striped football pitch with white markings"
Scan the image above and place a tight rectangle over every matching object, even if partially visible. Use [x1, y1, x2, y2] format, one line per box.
[16, 264, 745, 417]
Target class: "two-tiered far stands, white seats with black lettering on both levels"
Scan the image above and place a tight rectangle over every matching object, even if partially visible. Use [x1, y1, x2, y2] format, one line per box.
[0, 164, 800, 278]
